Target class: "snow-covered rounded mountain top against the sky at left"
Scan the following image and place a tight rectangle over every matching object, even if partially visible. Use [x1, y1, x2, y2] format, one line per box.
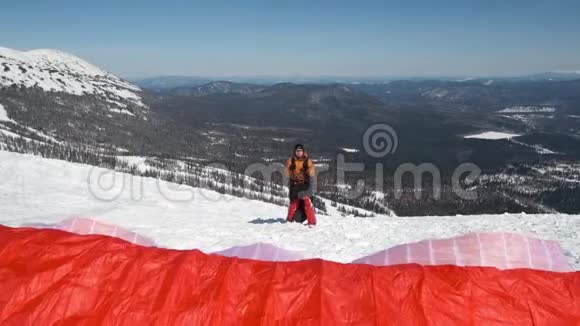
[0, 47, 143, 106]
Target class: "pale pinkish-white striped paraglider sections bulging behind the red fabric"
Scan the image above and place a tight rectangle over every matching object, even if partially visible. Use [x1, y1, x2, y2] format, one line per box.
[23, 217, 573, 272]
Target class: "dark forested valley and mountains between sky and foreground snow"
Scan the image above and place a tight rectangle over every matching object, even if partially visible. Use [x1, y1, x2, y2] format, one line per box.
[0, 49, 580, 216]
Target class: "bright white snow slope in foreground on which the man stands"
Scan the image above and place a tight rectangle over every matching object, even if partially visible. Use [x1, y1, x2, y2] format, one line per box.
[0, 151, 580, 269]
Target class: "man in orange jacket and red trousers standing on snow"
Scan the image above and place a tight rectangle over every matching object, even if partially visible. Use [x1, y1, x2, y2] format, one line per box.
[286, 144, 316, 226]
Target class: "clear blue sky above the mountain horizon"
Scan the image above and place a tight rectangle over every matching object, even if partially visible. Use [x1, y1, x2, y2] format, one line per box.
[0, 0, 580, 77]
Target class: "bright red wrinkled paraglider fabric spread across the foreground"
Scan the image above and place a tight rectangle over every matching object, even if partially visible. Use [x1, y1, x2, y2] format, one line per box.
[0, 226, 580, 326]
